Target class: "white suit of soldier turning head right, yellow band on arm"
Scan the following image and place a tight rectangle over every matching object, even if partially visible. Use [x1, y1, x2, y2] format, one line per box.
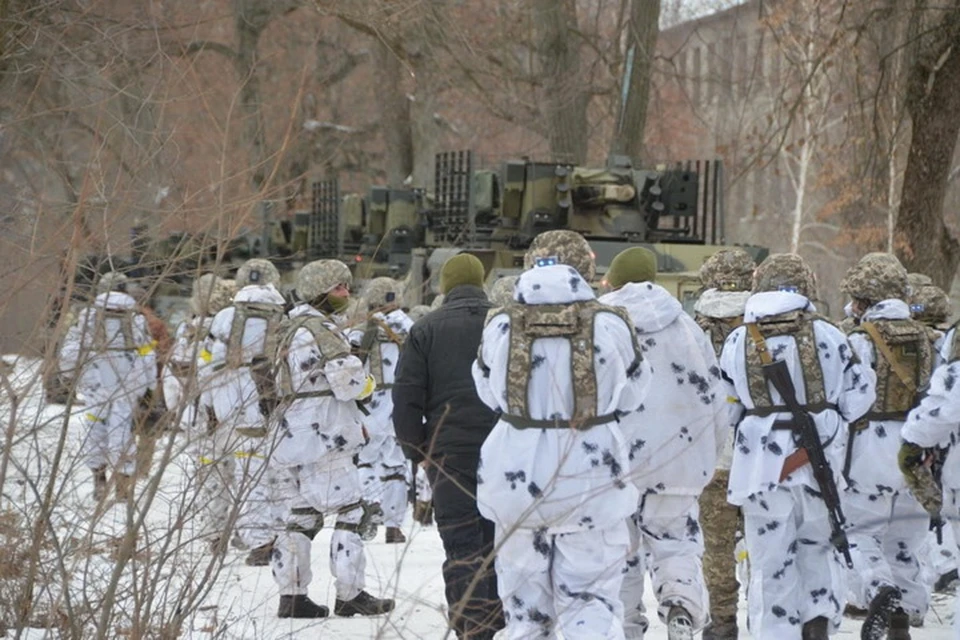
[270, 304, 367, 600]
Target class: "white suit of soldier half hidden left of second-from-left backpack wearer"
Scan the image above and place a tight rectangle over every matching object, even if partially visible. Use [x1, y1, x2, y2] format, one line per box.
[163, 315, 234, 536]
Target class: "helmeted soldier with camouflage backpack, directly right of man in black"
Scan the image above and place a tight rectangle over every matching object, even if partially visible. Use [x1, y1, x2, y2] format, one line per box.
[473, 230, 650, 638]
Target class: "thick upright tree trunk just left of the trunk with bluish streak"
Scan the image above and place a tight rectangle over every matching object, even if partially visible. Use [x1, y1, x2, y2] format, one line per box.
[533, 0, 590, 164]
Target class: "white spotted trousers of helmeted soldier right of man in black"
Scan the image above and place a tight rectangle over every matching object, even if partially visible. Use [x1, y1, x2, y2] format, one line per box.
[496, 522, 630, 640]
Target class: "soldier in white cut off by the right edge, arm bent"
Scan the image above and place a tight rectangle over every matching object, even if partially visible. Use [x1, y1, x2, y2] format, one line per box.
[898, 325, 960, 635]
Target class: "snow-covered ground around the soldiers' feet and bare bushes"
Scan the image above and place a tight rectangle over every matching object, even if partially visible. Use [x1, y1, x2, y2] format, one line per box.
[0, 363, 954, 640]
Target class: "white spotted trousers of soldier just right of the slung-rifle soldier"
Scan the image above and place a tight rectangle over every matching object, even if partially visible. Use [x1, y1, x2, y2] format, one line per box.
[843, 490, 930, 617]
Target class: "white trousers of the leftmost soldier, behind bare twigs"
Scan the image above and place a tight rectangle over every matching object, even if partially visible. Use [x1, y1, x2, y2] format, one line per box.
[81, 399, 136, 475]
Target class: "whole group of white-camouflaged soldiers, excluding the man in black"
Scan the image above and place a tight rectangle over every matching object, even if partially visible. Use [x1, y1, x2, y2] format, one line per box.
[61, 231, 960, 640]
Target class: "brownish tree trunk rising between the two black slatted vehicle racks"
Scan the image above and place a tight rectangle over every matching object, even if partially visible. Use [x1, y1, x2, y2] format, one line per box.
[373, 39, 414, 187]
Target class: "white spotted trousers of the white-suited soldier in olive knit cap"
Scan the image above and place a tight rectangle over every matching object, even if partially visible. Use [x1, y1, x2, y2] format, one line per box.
[620, 494, 710, 639]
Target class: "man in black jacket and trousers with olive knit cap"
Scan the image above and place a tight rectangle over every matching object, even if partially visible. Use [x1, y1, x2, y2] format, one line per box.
[393, 254, 503, 640]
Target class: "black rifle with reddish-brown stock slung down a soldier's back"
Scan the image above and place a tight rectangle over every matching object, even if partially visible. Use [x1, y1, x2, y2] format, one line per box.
[763, 360, 853, 569]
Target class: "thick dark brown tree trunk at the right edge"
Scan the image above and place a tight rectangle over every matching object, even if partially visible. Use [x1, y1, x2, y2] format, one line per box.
[896, 2, 960, 291]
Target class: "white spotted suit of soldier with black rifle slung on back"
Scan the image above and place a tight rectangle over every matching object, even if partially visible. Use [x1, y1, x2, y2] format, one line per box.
[720, 291, 876, 640]
